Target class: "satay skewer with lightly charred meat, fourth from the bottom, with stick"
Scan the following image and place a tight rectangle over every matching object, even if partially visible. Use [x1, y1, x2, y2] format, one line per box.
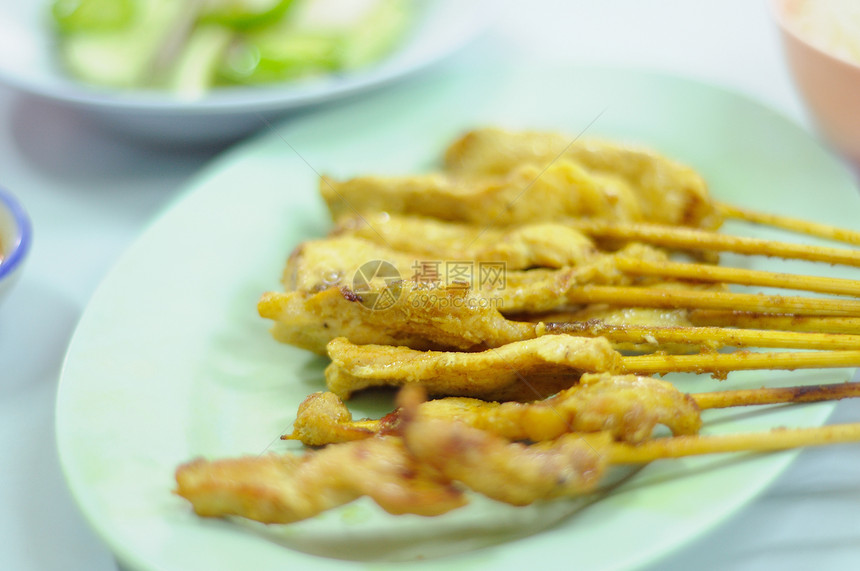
[258, 282, 860, 354]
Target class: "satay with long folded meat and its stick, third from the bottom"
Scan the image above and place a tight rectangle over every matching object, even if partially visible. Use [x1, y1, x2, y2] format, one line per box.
[325, 335, 860, 401]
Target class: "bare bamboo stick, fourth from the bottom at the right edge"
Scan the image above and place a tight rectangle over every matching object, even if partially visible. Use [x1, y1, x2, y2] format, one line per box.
[538, 321, 860, 351]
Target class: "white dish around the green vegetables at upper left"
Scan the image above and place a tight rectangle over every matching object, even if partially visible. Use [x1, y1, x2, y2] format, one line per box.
[0, 0, 493, 143]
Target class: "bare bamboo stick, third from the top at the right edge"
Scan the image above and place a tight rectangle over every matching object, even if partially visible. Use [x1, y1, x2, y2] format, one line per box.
[615, 258, 860, 297]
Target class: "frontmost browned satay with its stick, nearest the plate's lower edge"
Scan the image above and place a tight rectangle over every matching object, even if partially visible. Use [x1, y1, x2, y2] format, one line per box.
[176, 386, 860, 523]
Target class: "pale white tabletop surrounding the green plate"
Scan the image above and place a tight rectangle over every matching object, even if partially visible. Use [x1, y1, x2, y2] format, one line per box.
[0, 0, 860, 571]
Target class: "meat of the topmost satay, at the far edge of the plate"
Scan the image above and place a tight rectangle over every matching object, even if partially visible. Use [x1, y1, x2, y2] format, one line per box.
[445, 128, 722, 230]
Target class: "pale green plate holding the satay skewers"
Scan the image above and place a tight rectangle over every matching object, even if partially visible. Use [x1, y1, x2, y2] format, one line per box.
[57, 67, 860, 571]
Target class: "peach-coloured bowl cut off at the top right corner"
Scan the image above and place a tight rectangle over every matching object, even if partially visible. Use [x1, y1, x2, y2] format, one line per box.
[771, 0, 860, 164]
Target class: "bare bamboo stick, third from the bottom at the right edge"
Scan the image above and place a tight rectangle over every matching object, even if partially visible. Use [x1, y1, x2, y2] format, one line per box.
[622, 351, 860, 375]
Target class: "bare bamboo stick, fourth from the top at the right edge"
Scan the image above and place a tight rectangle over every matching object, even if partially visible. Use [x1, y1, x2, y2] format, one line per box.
[565, 285, 860, 316]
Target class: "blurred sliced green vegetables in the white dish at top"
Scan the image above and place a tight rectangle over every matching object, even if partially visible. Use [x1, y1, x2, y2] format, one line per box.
[51, 0, 412, 98]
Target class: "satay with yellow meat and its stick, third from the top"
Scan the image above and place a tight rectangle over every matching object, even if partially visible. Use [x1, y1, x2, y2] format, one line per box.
[330, 214, 860, 302]
